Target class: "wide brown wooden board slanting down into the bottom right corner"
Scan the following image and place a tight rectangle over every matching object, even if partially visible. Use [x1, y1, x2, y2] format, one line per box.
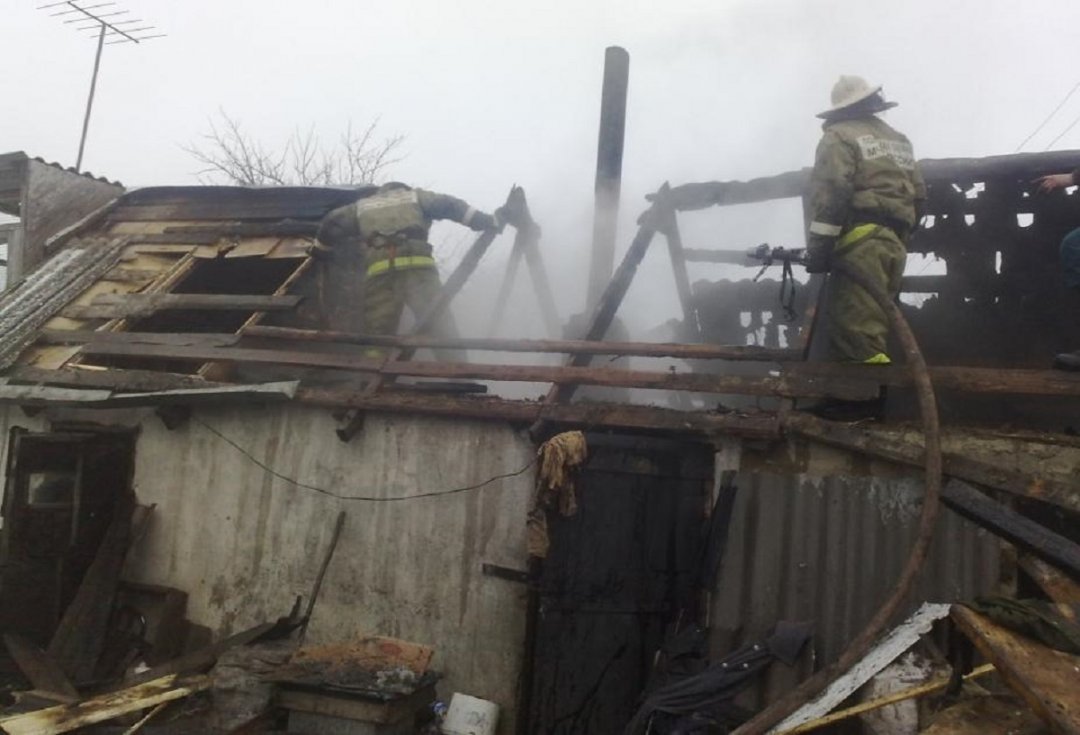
[951, 604, 1080, 735]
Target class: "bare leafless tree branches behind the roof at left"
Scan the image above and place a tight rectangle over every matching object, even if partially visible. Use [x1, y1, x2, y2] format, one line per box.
[183, 110, 405, 187]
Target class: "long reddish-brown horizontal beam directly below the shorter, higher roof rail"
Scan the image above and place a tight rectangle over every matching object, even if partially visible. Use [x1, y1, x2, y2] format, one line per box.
[73, 342, 877, 399]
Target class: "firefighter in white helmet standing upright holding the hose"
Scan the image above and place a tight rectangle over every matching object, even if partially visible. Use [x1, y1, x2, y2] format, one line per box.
[807, 77, 927, 365]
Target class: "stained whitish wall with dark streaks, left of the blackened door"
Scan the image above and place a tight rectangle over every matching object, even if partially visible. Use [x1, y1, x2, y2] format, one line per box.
[0, 406, 534, 732]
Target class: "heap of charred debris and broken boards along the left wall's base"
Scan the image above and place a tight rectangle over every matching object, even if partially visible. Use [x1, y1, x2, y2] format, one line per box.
[0, 505, 453, 735]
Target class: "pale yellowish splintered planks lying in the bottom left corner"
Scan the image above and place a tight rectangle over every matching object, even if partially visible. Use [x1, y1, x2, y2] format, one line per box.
[0, 676, 212, 735]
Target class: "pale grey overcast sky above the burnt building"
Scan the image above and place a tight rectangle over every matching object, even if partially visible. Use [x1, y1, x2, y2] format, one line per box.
[6, 0, 1080, 332]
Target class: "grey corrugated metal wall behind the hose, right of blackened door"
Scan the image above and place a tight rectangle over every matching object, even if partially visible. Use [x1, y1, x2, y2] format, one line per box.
[711, 472, 999, 704]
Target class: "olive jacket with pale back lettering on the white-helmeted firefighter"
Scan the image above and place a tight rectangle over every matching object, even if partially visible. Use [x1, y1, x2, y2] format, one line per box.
[809, 115, 927, 240]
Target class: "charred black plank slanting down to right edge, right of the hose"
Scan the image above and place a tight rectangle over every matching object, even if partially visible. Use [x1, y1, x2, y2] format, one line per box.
[942, 479, 1080, 575]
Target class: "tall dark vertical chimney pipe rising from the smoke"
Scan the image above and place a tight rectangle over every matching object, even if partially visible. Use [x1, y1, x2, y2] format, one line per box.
[585, 46, 630, 312]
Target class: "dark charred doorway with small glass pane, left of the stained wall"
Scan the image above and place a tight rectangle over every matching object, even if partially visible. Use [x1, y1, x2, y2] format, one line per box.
[0, 428, 134, 646]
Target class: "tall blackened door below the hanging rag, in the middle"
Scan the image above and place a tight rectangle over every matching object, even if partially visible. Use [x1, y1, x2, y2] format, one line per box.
[526, 435, 713, 735]
